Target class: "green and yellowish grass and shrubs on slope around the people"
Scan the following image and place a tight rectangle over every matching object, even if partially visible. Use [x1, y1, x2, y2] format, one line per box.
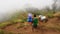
[0, 4, 60, 34]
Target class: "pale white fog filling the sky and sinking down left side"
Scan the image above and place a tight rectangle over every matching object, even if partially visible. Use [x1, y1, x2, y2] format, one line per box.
[0, 0, 53, 21]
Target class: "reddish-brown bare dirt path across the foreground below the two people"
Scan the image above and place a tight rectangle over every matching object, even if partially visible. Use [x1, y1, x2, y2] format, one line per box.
[3, 23, 60, 34]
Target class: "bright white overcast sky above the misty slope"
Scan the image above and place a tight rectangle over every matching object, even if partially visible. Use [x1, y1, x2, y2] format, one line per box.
[0, 0, 53, 12]
